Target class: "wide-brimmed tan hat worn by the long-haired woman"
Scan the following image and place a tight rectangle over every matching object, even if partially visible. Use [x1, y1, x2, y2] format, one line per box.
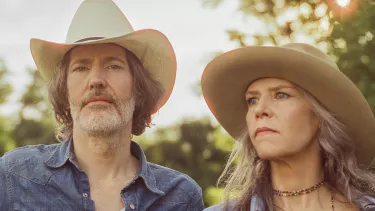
[201, 43, 375, 165]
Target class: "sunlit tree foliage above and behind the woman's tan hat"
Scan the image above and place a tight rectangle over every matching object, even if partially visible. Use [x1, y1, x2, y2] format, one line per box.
[203, 0, 375, 111]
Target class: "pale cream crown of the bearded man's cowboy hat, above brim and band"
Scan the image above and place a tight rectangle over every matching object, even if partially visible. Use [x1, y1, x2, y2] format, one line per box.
[66, 0, 134, 43]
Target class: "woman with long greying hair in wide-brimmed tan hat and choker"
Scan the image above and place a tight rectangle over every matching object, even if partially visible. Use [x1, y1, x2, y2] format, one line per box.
[202, 43, 375, 211]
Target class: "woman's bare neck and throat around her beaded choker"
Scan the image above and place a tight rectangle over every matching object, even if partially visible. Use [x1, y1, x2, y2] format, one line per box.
[270, 139, 332, 210]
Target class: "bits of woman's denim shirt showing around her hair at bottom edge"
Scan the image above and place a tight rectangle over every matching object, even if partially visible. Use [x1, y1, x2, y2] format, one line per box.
[204, 195, 375, 211]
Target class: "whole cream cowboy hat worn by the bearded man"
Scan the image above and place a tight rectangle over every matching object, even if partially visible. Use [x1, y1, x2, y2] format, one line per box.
[30, 0, 176, 113]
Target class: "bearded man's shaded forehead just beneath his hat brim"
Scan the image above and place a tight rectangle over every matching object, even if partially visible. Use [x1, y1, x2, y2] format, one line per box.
[70, 43, 126, 61]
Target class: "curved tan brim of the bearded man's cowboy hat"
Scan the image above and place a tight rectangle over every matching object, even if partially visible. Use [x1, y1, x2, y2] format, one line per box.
[30, 29, 177, 113]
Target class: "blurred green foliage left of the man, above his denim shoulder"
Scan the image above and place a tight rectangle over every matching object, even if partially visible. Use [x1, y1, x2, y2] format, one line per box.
[0, 63, 56, 155]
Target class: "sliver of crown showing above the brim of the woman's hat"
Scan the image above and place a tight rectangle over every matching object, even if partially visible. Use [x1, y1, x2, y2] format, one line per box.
[281, 43, 339, 70]
